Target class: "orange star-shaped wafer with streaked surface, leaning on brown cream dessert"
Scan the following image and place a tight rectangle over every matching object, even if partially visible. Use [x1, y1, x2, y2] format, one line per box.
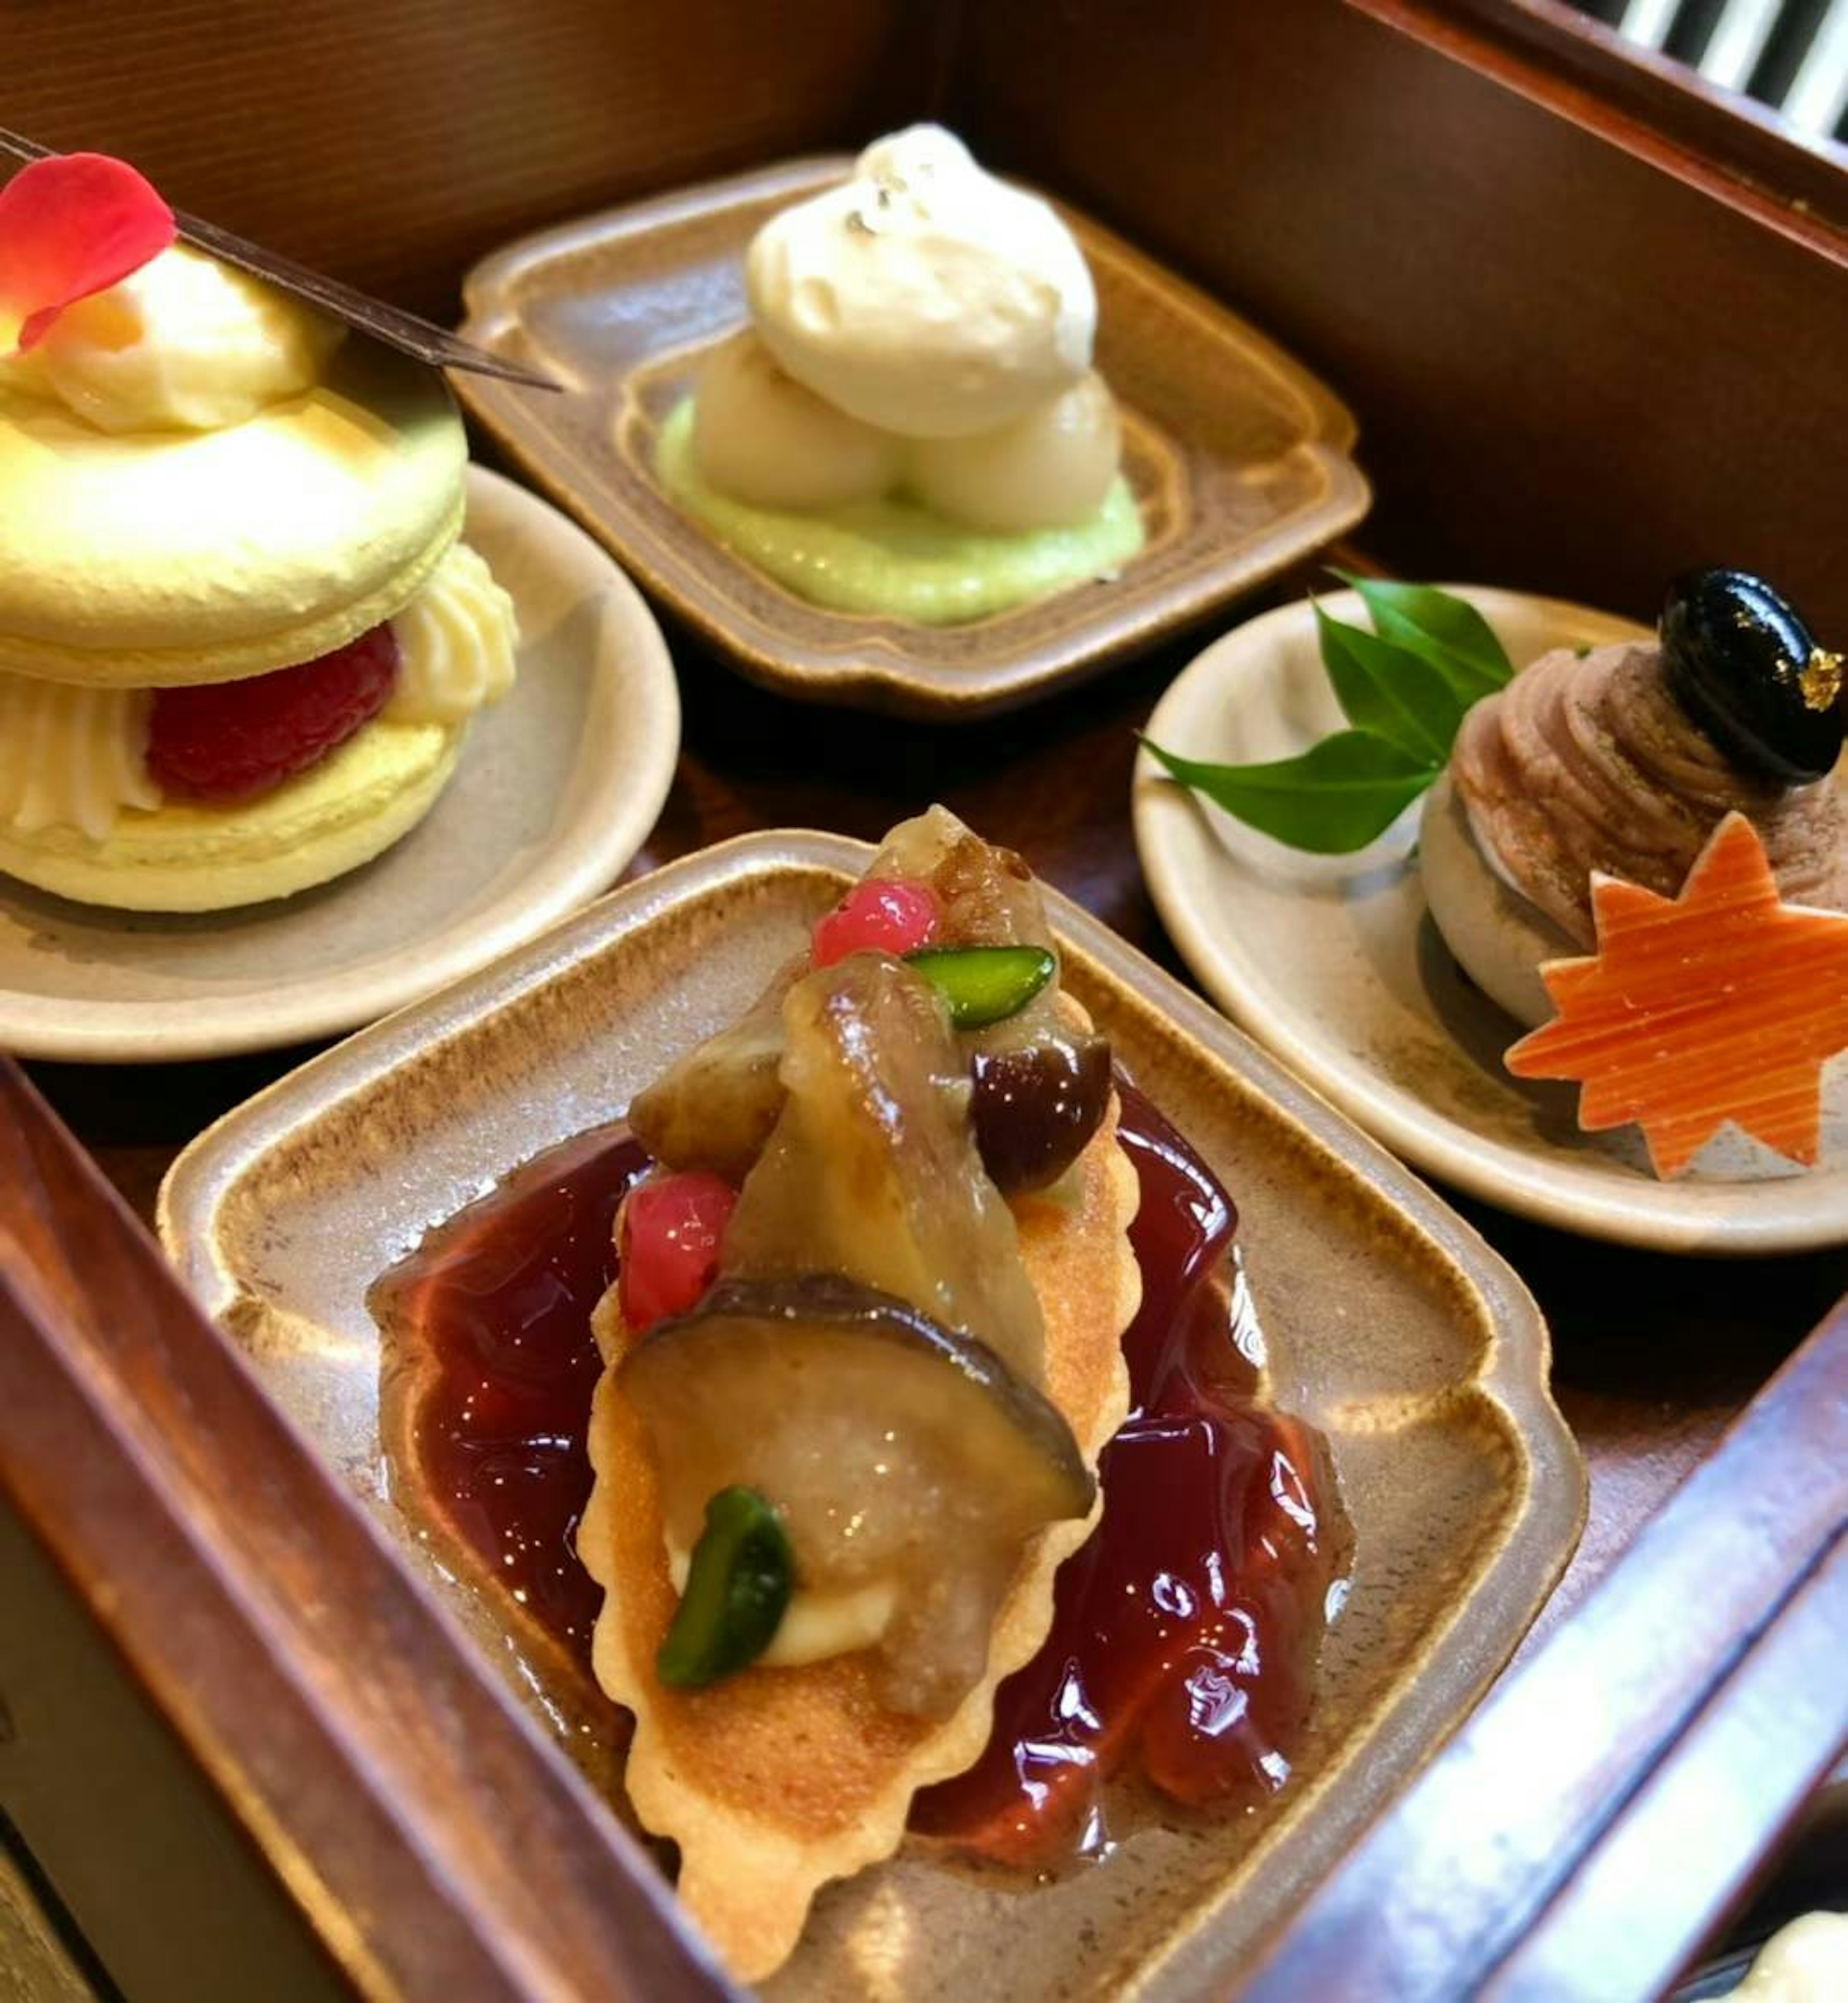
[1503, 813, 1848, 1176]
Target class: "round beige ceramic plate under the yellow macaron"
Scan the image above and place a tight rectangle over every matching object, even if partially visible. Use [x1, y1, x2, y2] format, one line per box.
[0, 467, 681, 1063]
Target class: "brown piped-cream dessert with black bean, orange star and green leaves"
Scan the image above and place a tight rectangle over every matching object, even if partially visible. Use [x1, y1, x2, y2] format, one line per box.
[1149, 569, 1848, 1176]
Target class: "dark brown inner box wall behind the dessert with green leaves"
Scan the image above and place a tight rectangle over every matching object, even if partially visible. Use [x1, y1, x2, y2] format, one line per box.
[953, 0, 1848, 633]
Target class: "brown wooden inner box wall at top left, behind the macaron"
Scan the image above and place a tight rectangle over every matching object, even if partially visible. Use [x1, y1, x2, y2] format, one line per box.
[0, 0, 955, 324]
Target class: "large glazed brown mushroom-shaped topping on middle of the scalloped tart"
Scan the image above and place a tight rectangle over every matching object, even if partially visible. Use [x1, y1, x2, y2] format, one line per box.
[621, 954, 1093, 1717]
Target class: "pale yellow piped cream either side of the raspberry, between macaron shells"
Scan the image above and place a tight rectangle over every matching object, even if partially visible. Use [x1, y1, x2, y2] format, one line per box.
[0, 543, 519, 841]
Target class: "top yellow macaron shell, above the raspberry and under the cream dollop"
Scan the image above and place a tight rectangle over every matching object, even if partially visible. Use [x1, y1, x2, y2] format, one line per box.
[0, 338, 466, 689]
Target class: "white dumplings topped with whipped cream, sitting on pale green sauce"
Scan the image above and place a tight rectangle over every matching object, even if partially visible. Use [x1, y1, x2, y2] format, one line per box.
[661, 126, 1143, 623]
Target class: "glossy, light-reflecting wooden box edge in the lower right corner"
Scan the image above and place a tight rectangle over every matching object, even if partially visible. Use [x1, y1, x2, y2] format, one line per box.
[1235, 1300, 1848, 2003]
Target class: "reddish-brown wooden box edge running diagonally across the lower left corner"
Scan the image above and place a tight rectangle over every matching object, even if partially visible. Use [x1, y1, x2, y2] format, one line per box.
[0, 1061, 735, 2003]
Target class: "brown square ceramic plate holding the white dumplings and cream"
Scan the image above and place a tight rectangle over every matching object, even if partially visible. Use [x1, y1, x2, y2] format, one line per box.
[457, 158, 1370, 717]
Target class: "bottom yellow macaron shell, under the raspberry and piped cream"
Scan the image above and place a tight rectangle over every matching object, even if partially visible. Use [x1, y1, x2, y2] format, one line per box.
[0, 717, 469, 911]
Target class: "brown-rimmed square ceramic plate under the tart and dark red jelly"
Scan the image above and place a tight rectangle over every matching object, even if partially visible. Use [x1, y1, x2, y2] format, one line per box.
[160, 833, 1584, 2003]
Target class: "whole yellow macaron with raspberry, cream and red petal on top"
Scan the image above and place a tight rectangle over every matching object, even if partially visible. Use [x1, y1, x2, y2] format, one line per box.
[0, 154, 516, 911]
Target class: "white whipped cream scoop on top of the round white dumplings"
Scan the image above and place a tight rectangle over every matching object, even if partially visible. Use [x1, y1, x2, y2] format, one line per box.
[745, 126, 1097, 439]
